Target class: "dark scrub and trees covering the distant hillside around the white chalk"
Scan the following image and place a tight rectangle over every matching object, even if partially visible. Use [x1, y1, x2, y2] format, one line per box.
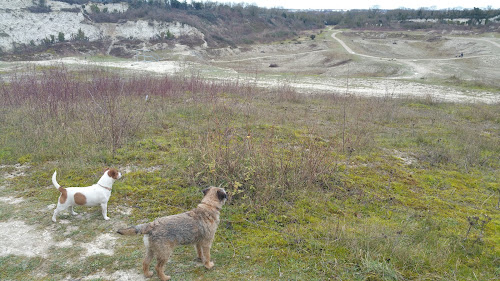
[4, 0, 500, 60]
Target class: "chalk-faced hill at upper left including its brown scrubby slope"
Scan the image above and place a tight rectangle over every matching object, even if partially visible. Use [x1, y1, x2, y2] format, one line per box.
[0, 0, 324, 59]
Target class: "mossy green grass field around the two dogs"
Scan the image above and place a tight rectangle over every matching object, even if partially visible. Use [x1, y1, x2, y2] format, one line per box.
[0, 65, 500, 280]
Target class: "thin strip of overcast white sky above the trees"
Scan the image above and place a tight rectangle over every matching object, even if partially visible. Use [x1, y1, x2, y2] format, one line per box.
[233, 0, 500, 10]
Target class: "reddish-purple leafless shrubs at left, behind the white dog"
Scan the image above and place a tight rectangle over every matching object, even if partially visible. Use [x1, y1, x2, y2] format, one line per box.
[0, 66, 243, 158]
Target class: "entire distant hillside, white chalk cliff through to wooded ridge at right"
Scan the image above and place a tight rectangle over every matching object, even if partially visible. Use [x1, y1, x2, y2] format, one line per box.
[0, 0, 500, 59]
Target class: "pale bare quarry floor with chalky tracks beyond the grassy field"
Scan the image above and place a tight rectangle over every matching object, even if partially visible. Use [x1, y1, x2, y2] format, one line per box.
[2, 31, 500, 103]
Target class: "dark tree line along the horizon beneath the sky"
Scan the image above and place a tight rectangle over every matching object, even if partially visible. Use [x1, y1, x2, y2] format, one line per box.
[51, 0, 500, 28]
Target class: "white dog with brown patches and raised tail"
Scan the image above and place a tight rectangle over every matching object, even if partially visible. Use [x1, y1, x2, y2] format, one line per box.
[52, 168, 122, 222]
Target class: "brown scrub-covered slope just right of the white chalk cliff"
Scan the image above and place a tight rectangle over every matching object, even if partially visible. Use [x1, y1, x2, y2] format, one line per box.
[88, 1, 324, 47]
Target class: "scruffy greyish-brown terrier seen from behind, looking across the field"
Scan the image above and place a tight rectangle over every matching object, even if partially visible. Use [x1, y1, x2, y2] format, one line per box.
[118, 187, 227, 281]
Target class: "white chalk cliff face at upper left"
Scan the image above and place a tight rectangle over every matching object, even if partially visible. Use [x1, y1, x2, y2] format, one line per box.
[0, 0, 204, 51]
